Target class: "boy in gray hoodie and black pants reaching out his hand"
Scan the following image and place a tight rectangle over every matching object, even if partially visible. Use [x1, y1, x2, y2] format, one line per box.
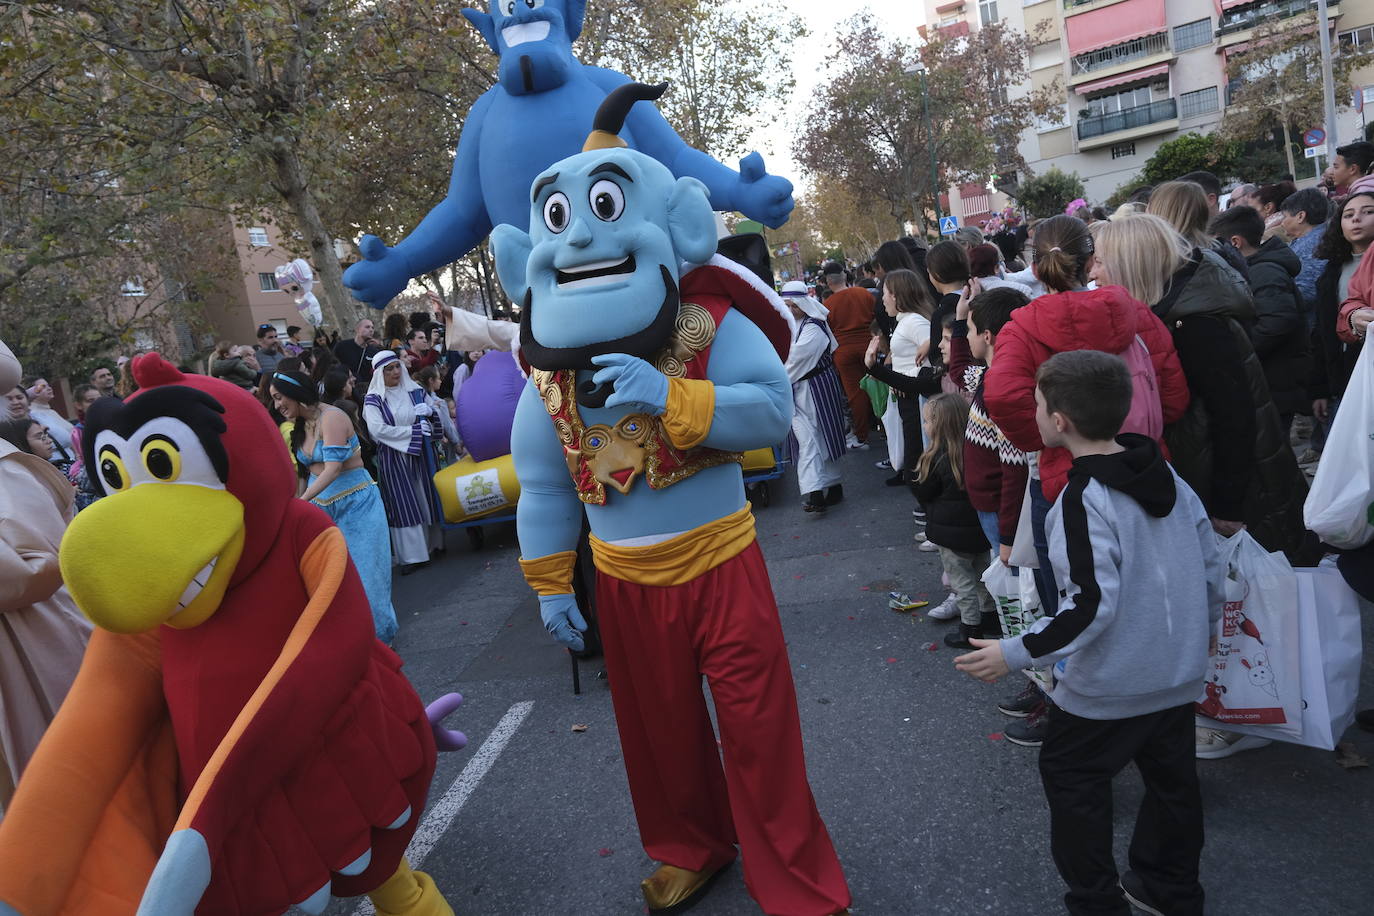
[955, 350, 1226, 916]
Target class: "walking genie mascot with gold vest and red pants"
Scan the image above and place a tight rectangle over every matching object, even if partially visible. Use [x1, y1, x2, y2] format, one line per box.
[492, 84, 849, 916]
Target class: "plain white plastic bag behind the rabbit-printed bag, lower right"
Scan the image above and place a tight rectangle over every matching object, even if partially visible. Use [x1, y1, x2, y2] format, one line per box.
[1226, 569, 1363, 751]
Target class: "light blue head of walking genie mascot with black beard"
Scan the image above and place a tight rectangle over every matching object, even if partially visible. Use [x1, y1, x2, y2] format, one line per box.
[492, 82, 716, 390]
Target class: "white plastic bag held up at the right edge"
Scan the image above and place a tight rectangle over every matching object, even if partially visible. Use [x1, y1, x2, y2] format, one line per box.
[1303, 343, 1374, 549]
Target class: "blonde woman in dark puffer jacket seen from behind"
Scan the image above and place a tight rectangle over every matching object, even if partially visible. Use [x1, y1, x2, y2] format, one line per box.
[1093, 214, 1307, 562]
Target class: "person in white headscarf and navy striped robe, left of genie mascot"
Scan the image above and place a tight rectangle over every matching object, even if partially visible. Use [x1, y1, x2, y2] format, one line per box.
[363, 350, 444, 575]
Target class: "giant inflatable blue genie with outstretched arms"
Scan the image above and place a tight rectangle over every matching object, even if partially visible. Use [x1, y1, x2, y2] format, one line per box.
[344, 0, 793, 309]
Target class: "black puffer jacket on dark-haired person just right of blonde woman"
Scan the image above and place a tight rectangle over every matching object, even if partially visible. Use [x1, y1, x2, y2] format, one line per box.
[1245, 239, 1311, 416]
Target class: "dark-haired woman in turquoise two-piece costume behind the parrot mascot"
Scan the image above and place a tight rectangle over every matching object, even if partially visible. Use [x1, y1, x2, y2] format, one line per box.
[271, 371, 397, 644]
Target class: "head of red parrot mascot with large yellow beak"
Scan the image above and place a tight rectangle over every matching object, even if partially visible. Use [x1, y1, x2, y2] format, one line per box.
[59, 353, 295, 633]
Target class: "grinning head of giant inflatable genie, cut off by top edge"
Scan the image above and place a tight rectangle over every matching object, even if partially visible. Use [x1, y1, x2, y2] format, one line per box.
[463, 0, 587, 95]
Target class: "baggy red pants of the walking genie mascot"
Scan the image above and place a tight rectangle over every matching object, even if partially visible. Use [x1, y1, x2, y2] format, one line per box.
[596, 542, 849, 916]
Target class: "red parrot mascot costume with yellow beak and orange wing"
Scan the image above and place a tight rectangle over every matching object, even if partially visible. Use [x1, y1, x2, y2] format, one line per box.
[0, 354, 452, 916]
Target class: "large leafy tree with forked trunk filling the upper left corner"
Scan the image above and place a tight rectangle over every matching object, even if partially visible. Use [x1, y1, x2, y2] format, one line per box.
[0, 0, 481, 340]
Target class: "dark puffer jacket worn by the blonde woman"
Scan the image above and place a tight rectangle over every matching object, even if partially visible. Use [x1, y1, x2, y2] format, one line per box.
[1153, 249, 1316, 563]
